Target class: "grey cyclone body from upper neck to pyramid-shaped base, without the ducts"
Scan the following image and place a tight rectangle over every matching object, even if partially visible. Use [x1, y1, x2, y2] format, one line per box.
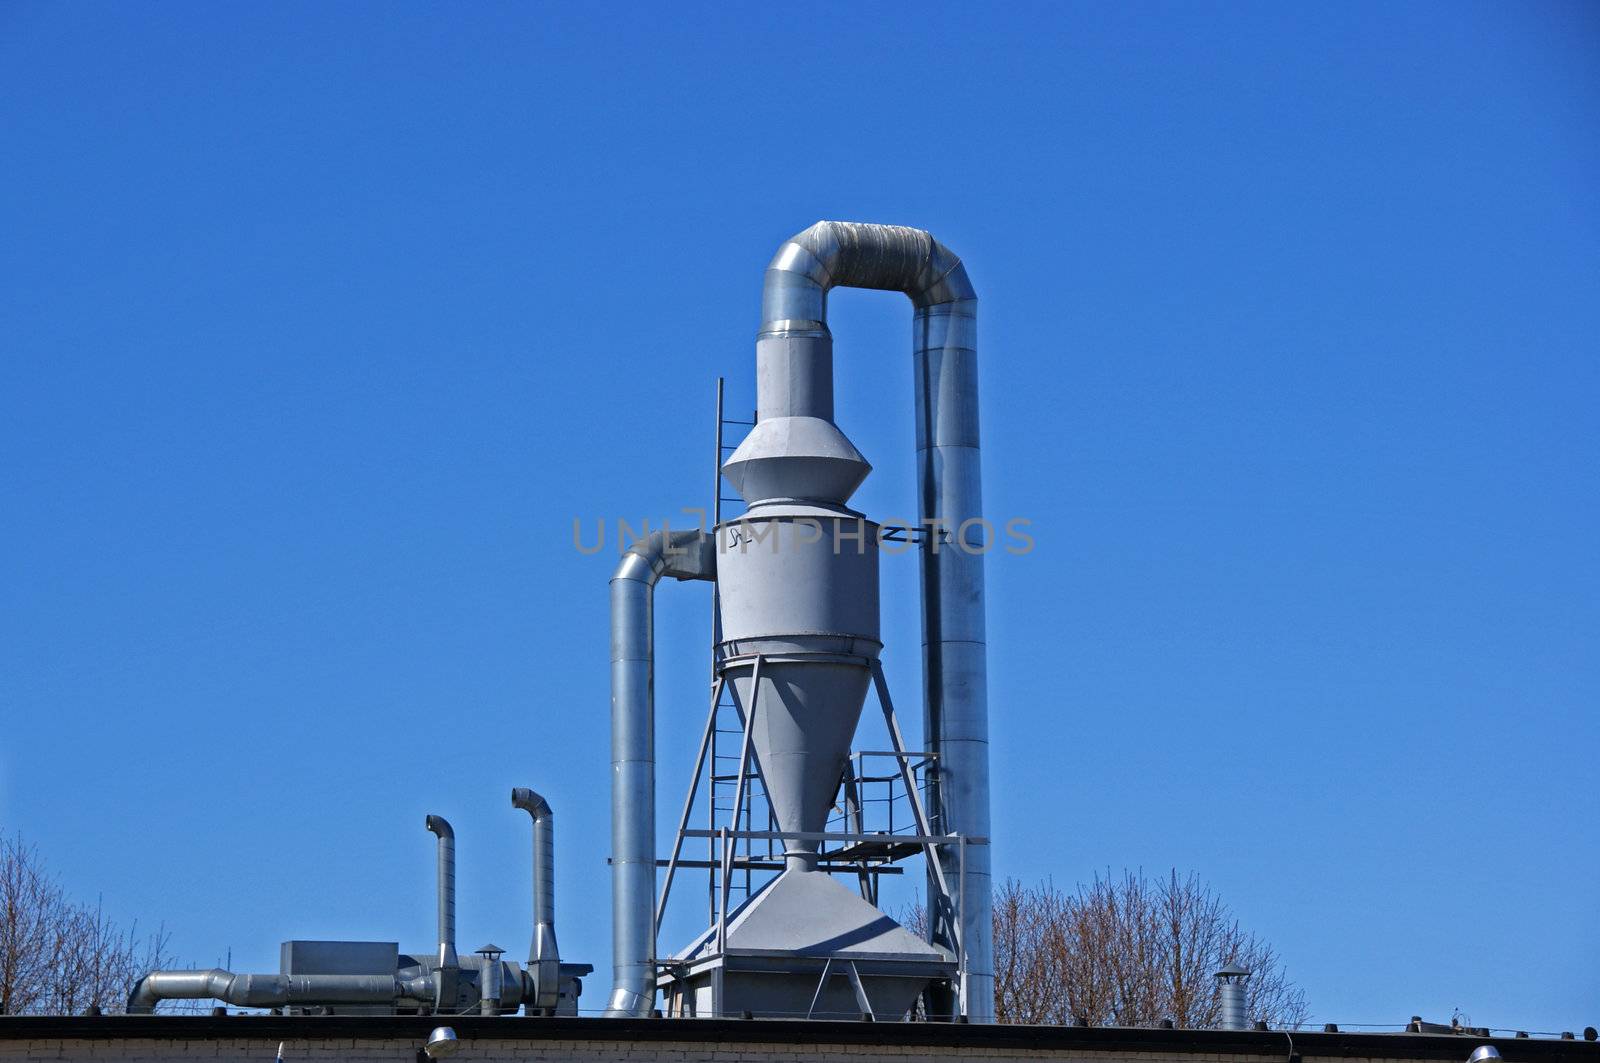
[659, 252, 957, 1018]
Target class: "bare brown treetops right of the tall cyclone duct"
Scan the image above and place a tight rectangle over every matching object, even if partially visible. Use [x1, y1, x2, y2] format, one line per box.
[907, 871, 1307, 1028]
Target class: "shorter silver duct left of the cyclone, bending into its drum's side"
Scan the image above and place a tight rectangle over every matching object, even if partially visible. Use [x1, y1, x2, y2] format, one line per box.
[606, 532, 717, 1017]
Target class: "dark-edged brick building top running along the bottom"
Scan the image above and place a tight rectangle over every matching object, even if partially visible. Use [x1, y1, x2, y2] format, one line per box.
[0, 1015, 1580, 1063]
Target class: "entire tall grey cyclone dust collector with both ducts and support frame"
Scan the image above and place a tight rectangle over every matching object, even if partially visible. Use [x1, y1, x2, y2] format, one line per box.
[608, 221, 994, 1021]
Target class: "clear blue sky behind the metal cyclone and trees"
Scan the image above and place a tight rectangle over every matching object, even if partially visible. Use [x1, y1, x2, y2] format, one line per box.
[0, 2, 1600, 1029]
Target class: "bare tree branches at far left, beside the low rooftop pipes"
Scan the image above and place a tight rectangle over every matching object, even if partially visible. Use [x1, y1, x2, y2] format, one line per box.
[0, 837, 168, 1015]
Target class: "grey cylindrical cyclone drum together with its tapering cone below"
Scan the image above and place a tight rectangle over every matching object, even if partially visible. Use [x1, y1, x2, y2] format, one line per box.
[717, 503, 882, 871]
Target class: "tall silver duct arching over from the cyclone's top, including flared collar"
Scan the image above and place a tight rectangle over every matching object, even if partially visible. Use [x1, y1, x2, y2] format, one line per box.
[725, 221, 994, 1021]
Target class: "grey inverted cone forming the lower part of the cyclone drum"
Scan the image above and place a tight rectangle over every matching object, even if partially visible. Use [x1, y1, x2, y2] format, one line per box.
[728, 661, 872, 853]
